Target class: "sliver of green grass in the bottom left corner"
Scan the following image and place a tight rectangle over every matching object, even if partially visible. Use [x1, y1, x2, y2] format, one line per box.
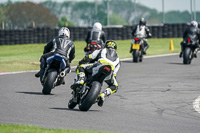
[0, 124, 108, 133]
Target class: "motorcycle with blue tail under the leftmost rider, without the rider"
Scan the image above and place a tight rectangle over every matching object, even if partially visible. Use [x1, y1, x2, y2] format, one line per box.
[40, 54, 70, 95]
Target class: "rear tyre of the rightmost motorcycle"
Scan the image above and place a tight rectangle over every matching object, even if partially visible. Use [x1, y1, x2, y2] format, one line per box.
[183, 47, 192, 64]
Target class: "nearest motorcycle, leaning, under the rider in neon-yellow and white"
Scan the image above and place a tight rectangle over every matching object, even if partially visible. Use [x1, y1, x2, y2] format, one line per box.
[68, 65, 112, 111]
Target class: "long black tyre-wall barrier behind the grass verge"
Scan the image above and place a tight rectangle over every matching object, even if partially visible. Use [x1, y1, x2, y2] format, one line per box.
[0, 24, 187, 45]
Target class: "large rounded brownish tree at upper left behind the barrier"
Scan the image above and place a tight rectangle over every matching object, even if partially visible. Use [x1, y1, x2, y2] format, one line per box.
[6, 2, 58, 28]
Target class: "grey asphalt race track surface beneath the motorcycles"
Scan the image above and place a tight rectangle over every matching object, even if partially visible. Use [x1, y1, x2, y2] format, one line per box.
[0, 54, 200, 133]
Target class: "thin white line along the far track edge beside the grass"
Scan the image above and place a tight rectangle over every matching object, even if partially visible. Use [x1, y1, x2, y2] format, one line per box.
[0, 53, 178, 76]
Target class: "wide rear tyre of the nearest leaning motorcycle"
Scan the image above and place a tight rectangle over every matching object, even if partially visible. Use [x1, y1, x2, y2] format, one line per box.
[79, 81, 101, 111]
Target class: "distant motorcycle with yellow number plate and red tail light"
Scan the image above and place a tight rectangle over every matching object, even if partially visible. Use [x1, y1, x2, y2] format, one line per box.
[131, 38, 144, 62]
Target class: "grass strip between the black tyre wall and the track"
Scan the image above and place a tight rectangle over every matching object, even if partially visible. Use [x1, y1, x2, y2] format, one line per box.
[0, 38, 182, 72]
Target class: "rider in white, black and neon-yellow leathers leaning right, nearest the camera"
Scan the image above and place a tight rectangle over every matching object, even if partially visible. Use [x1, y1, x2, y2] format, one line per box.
[71, 40, 120, 107]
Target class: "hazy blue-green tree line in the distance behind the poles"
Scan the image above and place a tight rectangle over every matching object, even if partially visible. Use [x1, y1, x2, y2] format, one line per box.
[42, 0, 200, 26]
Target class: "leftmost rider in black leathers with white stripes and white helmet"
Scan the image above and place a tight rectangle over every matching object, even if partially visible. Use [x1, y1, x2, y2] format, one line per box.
[35, 27, 75, 79]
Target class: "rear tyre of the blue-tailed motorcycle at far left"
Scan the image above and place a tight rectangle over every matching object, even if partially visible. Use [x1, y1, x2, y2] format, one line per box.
[42, 70, 57, 95]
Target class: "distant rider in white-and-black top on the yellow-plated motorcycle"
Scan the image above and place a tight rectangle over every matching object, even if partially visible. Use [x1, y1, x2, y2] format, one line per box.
[130, 18, 152, 54]
